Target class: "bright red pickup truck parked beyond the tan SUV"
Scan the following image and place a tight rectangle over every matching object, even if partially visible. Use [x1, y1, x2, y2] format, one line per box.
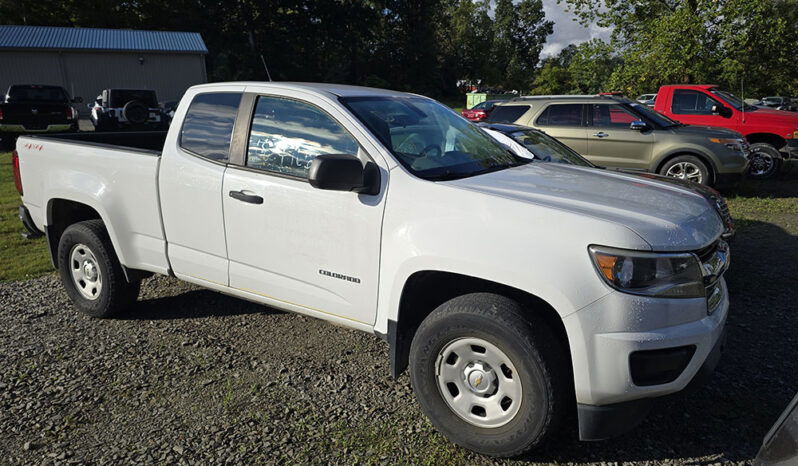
[654, 84, 798, 178]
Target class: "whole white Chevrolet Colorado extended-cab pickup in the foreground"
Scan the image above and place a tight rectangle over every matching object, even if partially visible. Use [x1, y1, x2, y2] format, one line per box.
[14, 82, 729, 456]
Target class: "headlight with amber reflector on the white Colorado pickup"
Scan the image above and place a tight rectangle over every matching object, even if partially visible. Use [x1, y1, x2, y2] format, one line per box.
[588, 246, 706, 298]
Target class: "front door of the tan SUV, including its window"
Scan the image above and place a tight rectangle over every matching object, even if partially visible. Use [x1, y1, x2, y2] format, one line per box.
[585, 103, 656, 170]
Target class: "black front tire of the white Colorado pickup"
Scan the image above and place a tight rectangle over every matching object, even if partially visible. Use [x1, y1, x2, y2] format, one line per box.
[410, 293, 572, 457]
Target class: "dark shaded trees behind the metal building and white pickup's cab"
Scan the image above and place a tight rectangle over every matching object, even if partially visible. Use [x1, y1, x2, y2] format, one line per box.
[0, 0, 552, 96]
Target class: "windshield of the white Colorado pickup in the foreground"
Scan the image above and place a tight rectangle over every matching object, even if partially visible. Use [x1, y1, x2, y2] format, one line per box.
[340, 96, 530, 181]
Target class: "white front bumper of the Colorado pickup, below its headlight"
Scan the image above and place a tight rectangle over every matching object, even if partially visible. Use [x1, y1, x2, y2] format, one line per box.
[563, 279, 729, 440]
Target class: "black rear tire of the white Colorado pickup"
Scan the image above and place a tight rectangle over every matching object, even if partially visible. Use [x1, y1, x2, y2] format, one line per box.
[58, 220, 141, 318]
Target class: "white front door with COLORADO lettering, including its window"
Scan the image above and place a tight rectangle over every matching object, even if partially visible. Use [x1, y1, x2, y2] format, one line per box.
[222, 95, 385, 325]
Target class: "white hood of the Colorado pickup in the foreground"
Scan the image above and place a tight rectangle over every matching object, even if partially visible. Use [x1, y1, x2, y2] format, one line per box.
[444, 162, 723, 251]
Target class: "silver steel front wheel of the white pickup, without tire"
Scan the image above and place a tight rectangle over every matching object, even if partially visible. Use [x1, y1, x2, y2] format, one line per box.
[436, 338, 522, 427]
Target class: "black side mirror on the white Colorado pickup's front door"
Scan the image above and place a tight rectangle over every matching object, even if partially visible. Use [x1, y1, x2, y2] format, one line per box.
[308, 154, 380, 195]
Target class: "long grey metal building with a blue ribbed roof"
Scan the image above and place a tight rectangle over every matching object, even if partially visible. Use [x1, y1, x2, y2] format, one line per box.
[0, 25, 208, 114]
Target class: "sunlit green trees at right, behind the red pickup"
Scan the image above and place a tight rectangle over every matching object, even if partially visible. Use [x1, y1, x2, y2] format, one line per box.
[532, 0, 798, 98]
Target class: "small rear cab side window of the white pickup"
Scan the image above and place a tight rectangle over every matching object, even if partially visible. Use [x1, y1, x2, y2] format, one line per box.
[179, 92, 241, 163]
